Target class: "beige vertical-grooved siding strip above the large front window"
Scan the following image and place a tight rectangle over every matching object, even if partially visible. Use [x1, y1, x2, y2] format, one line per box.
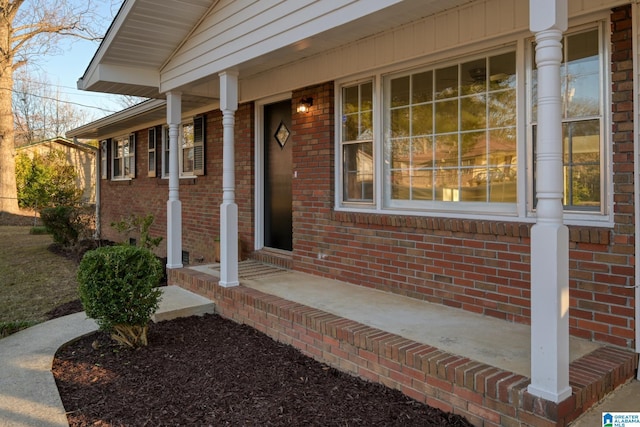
[240, 0, 625, 101]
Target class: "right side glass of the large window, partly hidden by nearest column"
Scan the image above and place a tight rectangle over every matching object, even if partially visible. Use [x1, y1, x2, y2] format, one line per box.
[530, 28, 605, 212]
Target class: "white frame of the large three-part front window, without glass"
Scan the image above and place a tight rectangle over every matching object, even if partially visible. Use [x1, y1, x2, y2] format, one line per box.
[334, 14, 613, 227]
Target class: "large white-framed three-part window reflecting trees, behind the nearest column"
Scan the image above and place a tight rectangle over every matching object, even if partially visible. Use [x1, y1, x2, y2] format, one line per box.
[336, 21, 612, 223]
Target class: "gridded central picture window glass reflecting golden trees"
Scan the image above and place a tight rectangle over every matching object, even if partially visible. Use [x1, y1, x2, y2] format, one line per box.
[384, 52, 518, 206]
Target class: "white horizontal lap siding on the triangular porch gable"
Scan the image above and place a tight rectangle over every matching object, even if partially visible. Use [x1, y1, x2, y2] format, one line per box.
[161, 0, 400, 91]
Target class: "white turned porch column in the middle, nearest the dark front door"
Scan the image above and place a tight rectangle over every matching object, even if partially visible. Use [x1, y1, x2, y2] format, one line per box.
[219, 71, 240, 287]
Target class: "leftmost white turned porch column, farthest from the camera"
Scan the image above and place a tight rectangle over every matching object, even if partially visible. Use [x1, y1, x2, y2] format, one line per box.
[167, 92, 182, 268]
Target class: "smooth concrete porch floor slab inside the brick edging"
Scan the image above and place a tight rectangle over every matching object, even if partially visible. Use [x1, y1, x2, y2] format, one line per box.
[189, 261, 600, 377]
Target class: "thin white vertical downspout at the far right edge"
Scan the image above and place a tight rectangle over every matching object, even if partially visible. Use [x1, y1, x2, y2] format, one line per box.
[631, 1, 640, 380]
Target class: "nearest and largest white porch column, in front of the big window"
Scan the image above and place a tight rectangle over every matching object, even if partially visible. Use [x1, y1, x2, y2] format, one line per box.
[528, 0, 571, 402]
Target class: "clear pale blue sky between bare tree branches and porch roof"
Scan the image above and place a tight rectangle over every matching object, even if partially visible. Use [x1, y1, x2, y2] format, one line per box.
[19, 0, 125, 120]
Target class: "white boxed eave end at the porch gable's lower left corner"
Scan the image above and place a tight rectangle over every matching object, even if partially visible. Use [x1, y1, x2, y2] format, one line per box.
[78, 64, 160, 90]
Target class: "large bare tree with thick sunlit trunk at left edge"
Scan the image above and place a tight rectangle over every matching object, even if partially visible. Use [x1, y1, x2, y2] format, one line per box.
[0, 0, 112, 213]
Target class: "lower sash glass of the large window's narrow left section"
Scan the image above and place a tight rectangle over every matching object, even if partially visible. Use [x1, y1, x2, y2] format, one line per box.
[343, 142, 373, 201]
